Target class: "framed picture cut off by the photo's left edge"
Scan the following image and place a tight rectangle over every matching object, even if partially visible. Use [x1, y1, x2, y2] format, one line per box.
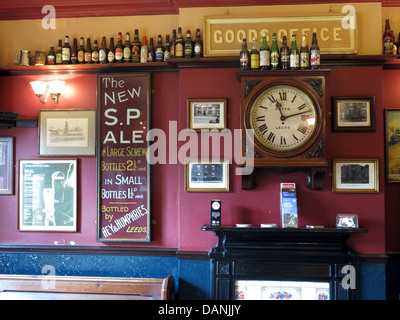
[0, 137, 14, 195]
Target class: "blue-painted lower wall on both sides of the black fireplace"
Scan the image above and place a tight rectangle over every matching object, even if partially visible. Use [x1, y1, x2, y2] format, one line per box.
[0, 251, 390, 300]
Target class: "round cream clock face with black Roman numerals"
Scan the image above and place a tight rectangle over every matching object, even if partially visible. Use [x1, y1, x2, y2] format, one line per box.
[250, 85, 318, 153]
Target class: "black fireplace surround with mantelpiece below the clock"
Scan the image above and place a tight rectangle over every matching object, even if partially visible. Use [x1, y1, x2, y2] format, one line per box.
[201, 226, 367, 300]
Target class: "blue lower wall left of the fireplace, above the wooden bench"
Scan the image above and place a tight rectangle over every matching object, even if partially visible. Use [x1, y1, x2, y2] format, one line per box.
[0, 252, 211, 300]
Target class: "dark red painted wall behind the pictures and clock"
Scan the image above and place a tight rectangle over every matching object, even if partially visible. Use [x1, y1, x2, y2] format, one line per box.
[0, 67, 386, 253]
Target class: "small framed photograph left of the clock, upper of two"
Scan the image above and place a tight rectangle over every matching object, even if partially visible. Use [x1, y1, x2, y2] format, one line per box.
[187, 99, 227, 131]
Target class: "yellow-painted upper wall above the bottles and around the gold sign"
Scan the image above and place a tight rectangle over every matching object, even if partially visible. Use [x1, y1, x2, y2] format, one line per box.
[0, 3, 390, 65]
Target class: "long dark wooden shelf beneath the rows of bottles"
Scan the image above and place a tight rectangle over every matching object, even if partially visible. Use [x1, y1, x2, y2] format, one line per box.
[0, 54, 400, 76]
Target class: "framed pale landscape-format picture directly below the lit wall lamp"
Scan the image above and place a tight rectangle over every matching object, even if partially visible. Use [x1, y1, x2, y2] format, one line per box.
[39, 110, 96, 157]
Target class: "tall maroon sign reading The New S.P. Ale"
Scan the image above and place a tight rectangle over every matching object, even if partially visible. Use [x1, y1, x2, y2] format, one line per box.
[97, 73, 151, 242]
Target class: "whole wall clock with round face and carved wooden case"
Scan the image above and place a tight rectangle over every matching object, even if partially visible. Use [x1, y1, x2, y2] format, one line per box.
[237, 69, 329, 189]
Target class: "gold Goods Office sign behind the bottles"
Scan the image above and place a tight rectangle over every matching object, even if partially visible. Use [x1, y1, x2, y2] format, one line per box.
[204, 15, 357, 56]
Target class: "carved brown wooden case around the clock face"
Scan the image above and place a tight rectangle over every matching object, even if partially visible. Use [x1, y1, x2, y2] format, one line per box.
[236, 69, 330, 189]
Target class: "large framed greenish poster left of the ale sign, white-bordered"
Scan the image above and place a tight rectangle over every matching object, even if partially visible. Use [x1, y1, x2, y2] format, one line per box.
[18, 159, 77, 232]
